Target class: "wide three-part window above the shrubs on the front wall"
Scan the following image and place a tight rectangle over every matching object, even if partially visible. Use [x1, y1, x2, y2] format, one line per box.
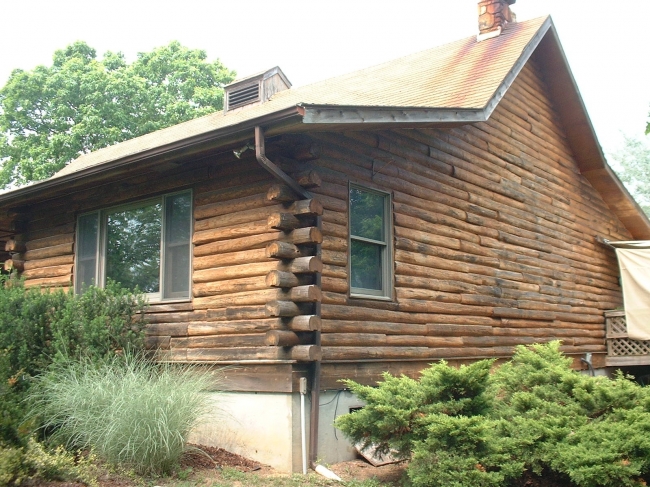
[75, 192, 192, 301]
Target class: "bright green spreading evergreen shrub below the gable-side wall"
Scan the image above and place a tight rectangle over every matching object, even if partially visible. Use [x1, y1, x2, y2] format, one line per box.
[336, 342, 650, 487]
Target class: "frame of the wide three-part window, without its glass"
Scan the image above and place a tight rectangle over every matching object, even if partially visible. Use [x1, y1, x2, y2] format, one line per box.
[74, 190, 194, 302]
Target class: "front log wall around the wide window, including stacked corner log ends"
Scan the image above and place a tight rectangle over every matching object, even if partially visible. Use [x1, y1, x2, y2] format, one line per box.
[5, 139, 322, 366]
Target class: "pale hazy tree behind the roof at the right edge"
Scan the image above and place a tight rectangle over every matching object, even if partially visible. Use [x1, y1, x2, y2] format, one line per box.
[613, 137, 650, 215]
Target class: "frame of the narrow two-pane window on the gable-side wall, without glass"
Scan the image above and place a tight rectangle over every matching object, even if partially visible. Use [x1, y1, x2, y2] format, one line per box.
[348, 182, 393, 301]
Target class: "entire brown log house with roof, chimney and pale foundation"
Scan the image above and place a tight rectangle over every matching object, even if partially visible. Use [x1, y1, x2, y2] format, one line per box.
[0, 0, 650, 471]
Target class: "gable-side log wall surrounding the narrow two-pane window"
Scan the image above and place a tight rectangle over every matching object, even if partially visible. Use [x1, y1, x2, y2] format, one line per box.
[313, 62, 630, 364]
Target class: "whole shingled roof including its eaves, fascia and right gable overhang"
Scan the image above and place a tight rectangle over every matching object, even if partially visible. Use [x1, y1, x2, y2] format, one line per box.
[0, 17, 650, 239]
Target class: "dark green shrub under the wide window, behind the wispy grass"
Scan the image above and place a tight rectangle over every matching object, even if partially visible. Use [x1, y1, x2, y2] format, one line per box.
[0, 279, 145, 446]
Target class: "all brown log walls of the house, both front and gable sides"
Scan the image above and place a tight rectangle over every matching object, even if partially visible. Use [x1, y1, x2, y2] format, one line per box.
[0, 52, 630, 387]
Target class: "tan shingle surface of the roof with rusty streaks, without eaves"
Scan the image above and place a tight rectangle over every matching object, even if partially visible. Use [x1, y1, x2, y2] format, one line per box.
[52, 17, 548, 182]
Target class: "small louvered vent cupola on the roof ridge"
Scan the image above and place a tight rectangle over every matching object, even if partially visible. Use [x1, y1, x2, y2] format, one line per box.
[223, 66, 291, 113]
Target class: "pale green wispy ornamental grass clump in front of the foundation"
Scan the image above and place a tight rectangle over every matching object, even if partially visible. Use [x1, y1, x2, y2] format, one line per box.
[30, 353, 215, 474]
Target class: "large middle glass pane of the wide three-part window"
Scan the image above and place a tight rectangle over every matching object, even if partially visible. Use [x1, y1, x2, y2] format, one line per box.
[106, 203, 162, 293]
